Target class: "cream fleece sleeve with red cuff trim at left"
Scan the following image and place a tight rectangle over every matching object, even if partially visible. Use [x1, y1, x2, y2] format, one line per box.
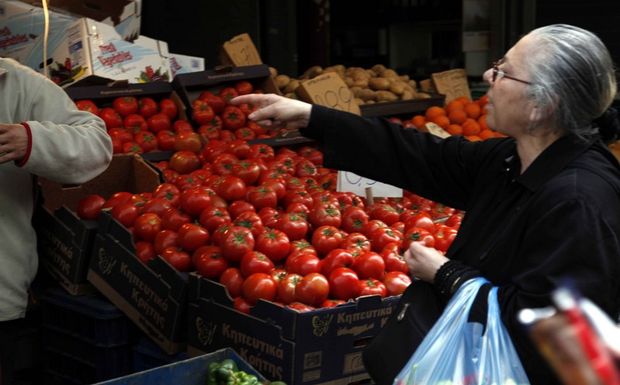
[16, 69, 112, 184]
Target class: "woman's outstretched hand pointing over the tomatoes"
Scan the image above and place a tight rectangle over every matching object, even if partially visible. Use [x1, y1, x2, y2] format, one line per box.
[230, 94, 312, 130]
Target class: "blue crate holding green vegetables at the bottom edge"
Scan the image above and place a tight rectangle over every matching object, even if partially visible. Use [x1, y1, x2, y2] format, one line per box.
[96, 348, 265, 385]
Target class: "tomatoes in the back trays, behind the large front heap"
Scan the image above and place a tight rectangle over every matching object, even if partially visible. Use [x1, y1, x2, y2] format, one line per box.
[76, 80, 277, 154]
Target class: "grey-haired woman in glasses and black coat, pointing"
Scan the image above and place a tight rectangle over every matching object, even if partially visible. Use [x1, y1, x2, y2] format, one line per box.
[235, 25, 620, 384]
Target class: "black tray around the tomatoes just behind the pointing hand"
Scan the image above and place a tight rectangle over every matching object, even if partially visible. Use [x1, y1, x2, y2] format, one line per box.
[172, 64, 280, 126]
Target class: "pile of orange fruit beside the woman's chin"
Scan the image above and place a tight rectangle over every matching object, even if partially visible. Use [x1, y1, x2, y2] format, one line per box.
[405, 95, 504, 141]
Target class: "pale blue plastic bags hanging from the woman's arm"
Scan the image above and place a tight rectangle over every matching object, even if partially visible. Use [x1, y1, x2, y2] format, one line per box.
[394, 278, 529, 385]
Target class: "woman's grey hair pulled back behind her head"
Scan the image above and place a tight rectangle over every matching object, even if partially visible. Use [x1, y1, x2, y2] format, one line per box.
[526, 24, 617, 136]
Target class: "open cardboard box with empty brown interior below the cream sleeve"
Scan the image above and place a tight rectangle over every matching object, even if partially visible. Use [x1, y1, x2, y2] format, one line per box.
[34, 155, 161, 295]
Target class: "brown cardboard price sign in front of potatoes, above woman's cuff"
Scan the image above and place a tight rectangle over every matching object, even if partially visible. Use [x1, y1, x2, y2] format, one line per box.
[295, 72, 361, 115]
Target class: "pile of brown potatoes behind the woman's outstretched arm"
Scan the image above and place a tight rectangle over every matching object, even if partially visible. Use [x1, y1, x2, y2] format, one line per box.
[270, 64, 430, 105]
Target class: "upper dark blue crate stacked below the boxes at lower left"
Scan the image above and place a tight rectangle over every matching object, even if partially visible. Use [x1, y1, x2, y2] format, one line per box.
[41, 288, 134, 347]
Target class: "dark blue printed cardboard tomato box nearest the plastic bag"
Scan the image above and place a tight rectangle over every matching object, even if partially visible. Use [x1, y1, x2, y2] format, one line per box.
[188, 273, 399, 385]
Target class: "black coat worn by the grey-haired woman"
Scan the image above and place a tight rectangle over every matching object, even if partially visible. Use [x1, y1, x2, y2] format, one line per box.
[301, 106, 620, 385]
